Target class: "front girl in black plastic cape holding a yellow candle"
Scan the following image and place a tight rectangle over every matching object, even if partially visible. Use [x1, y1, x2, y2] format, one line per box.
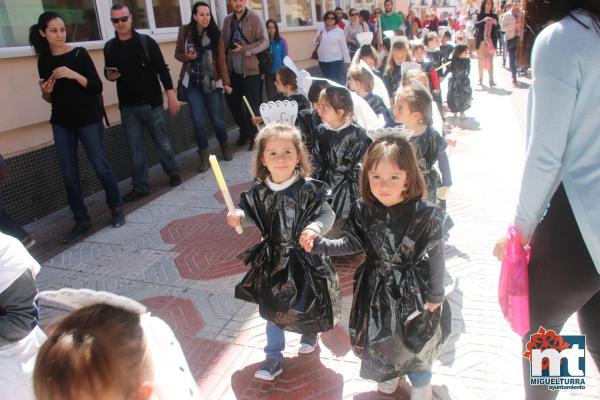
[227, 124, 341, 380]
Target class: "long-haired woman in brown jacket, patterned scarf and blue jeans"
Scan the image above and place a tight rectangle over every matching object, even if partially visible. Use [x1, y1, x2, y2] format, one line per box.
[175, 1, 232, 172]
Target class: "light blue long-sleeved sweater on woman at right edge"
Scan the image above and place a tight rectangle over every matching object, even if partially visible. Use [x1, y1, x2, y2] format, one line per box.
[515, 11, 600, 273]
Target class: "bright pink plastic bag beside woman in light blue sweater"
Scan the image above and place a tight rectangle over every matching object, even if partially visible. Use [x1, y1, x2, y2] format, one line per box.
[498, 226, 531, 336]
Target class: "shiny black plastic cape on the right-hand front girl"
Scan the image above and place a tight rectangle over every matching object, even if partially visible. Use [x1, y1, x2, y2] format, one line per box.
[346, 201, 451, 382]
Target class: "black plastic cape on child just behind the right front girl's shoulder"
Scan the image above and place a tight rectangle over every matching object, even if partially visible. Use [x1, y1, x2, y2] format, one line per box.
[410, 126, 448, 203]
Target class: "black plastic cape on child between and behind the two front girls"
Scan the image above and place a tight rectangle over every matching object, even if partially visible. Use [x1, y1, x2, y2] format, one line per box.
[314, 124, 371, 221]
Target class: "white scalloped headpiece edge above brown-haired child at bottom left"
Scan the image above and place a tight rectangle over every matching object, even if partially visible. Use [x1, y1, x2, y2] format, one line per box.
[35, 288, 148, 314]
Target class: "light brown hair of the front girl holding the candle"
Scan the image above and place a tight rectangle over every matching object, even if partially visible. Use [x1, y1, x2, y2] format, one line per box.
[252, 122, 312, 182]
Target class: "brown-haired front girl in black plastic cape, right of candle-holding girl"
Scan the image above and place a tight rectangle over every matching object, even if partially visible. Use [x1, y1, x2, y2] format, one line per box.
[303, 136, 451, 398]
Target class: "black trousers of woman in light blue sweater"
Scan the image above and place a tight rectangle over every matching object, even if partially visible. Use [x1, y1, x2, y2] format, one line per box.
[523, 184, 600, 400]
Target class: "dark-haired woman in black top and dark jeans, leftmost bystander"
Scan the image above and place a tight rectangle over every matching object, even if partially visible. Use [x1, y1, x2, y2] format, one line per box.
[29, 11, 125, 242]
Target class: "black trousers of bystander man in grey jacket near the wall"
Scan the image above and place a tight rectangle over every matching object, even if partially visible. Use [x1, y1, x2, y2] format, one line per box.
[225, 72, 262, 139]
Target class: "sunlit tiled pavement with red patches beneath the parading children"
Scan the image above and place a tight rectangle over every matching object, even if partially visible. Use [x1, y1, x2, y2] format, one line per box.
[38, 60, 600, 400]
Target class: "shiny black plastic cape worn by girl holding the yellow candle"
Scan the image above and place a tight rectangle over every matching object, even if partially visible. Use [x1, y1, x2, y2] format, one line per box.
[235, 178, 342, 333]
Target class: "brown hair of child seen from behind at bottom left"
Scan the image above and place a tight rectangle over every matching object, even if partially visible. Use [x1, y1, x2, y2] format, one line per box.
[33, 304, 153, 400]
